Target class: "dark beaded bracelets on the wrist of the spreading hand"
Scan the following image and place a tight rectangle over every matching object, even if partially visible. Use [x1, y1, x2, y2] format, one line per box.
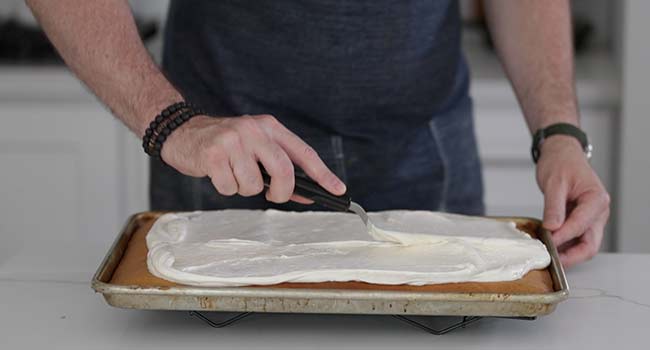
[142, 102, 203, 159]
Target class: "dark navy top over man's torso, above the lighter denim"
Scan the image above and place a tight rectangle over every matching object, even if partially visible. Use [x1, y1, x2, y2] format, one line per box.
[164, 0, 468, 140]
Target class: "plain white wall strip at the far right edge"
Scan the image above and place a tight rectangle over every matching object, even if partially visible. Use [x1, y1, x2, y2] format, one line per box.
[614, 0, 650, 253]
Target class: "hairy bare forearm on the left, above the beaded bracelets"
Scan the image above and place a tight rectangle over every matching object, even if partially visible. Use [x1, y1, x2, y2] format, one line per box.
[26, 0, 182, 136]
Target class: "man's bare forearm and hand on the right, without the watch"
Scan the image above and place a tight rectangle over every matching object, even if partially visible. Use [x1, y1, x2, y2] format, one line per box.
[484, 0, 609, 266]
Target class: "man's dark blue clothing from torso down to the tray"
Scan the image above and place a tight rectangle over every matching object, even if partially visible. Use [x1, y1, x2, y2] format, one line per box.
[150, 0, 484, 214]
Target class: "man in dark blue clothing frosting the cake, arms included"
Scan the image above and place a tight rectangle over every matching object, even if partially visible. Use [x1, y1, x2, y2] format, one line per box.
[27, 0, 609, 265]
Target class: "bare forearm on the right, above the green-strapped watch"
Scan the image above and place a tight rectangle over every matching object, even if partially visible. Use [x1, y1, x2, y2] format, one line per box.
[484, 0, 579, 132]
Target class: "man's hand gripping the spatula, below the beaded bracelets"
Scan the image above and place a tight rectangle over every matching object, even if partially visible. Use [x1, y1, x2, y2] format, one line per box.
[161, 115, 346, 203]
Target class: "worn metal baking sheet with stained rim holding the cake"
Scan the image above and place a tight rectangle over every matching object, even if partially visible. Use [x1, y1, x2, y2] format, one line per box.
[92, 212, 568, 317]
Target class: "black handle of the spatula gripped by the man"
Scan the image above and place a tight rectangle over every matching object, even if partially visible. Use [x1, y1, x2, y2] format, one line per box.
[260, 165, 350, 211]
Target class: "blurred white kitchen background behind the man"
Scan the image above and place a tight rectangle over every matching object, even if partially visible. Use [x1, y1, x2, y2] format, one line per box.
[0, 0, 650, 279]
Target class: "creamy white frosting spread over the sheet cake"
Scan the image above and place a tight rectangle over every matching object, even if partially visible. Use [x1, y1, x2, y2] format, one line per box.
[147, 209, 550, 287]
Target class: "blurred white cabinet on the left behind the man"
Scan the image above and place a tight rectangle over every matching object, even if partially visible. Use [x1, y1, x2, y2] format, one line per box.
[0, 69, 146, 280]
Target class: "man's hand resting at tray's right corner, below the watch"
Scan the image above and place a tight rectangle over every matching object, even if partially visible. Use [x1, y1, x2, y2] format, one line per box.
[537, 135, 610, 267]
